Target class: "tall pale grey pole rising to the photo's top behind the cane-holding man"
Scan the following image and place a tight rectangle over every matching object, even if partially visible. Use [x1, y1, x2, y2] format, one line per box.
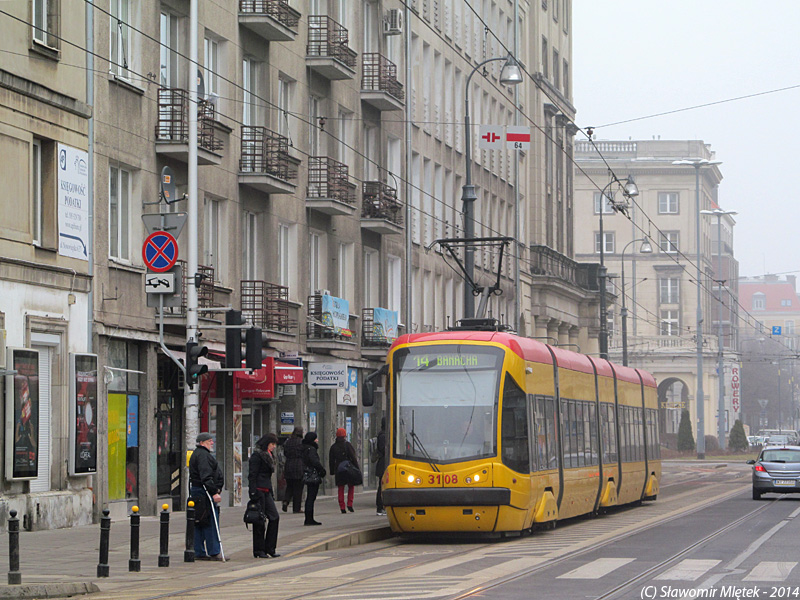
[185, 0, 200, 504]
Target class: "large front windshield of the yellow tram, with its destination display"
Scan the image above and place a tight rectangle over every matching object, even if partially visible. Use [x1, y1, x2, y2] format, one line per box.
[393, 344, 503, 463]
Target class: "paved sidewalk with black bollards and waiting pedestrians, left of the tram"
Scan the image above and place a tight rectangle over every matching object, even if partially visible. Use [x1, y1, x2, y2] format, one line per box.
[0, 491, 392, 598]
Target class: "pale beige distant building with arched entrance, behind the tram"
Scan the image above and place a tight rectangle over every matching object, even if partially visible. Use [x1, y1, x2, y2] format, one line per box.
[575, 140, 741, 446]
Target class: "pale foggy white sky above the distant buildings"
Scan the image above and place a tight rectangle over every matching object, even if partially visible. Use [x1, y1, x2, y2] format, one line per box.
[571, 0, 800, 276]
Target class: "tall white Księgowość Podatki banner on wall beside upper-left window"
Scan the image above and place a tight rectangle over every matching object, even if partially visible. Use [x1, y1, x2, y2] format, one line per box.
[57, 144, 89, 260]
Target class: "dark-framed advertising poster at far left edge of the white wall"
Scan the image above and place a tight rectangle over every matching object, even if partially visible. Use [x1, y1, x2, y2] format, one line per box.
[6, 348, 39, 479]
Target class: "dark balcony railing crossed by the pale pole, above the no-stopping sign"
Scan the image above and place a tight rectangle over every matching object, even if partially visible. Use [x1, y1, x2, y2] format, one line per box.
[156, 88, 222, 152]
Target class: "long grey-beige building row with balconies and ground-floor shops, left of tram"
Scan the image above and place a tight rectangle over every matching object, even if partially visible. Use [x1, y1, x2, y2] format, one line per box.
[0, 0, 598, 529]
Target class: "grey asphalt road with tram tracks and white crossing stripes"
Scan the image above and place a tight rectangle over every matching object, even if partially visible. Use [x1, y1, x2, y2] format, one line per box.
[78, 461, 780, 600]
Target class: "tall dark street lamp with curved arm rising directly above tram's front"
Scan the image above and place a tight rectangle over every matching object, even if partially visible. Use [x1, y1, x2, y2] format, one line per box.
[461, 54, 522, 319]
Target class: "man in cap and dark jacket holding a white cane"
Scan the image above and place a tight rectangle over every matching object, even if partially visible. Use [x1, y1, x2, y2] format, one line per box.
[189, 432, 225, 562]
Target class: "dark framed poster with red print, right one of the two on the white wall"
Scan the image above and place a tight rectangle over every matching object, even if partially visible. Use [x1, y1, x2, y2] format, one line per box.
[69, 353, 97, 475]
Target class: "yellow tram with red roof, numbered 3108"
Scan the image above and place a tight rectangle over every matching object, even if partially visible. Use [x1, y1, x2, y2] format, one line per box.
[372, 330, 661, 533]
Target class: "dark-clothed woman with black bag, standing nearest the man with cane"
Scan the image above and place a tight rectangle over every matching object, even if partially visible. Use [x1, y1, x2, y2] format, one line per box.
[247, 433, 280, 558]
